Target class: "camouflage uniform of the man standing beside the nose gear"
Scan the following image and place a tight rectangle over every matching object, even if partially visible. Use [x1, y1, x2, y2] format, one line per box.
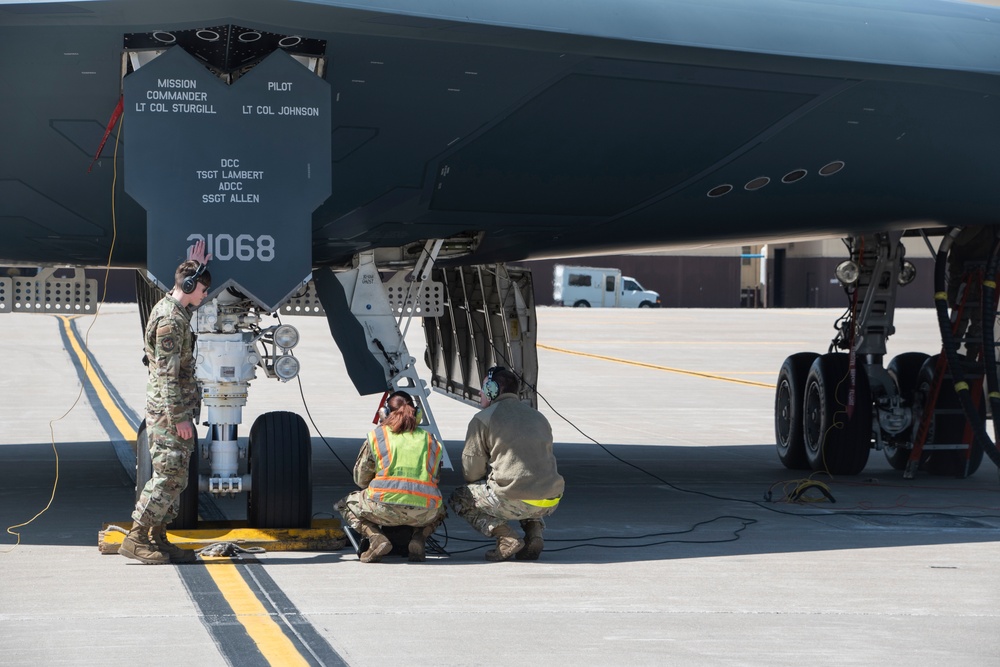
[132, 295, 201, 526]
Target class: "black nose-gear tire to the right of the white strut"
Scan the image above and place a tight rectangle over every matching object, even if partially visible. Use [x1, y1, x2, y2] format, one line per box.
[247, 412, 312, 528]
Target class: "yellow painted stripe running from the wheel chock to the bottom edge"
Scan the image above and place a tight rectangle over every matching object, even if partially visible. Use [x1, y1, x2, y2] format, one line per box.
[205, 558, 309, 665]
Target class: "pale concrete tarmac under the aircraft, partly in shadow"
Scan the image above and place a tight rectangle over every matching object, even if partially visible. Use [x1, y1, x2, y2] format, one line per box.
[0, 305, 1000, 667]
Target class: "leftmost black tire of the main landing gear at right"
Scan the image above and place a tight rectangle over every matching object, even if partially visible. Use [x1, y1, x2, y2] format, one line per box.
[774, 352, 819, 470]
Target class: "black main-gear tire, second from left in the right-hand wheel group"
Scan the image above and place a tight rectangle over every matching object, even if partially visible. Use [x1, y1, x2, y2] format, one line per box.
[803, 354, 872, 475]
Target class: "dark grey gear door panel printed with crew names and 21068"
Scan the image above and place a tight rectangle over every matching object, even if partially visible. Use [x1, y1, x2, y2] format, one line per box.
[124, 47, 331, 311]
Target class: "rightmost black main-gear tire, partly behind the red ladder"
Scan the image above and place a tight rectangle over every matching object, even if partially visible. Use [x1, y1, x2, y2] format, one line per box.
[918, 355, 986, 477]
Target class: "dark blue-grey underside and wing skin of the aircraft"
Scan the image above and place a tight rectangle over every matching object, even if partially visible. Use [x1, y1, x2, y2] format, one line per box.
[0, 0, 1000, 276]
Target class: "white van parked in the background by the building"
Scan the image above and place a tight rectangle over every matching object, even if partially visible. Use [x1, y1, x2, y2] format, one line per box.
[552, 264, 660, 308]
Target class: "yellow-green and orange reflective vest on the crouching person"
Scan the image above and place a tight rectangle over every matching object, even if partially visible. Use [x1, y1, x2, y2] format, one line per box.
[368, 426, 441, 507]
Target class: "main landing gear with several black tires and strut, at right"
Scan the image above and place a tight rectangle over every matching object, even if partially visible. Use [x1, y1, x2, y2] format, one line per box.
[774, 230, 1000, 478]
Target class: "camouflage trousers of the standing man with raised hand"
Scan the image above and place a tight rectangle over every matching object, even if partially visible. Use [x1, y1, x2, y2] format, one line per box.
[132, 415, 195, 526]
